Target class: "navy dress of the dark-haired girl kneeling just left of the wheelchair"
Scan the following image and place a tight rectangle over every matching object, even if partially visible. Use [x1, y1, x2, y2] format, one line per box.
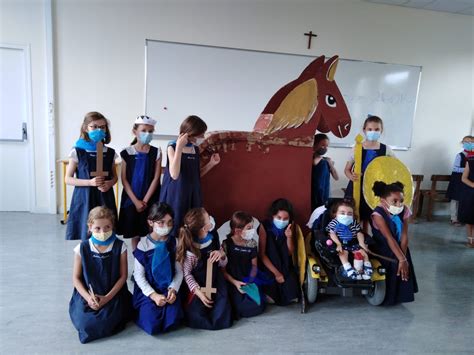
[261, 221, 299, 306]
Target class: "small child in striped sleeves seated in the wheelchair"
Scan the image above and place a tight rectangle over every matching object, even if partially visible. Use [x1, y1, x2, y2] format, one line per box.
[326, 201, 373, 280]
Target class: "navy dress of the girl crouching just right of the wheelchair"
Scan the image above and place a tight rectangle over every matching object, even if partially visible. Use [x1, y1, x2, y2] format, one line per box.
[371, 206, 418, 306]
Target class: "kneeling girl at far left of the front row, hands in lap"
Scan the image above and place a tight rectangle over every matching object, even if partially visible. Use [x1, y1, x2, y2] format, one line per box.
[69, 207, 132, 343]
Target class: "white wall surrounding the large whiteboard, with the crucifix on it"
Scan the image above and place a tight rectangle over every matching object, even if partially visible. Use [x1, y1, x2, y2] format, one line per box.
[54, 0, 474, 213]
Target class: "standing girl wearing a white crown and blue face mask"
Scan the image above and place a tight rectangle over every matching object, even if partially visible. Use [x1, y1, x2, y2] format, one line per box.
[117, 116, 161, 249]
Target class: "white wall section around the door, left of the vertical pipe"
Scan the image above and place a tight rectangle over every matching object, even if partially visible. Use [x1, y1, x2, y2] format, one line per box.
[0, 0, 56, 213]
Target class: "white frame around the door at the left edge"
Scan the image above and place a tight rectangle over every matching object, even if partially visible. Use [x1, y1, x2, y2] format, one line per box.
[0, 42, 36, 212]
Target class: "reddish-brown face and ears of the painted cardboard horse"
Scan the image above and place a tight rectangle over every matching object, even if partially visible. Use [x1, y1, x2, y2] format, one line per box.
[312, 56, 351, 138]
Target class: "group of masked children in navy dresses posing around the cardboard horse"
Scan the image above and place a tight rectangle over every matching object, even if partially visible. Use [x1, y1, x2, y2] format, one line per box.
[66, 112, 466, 342]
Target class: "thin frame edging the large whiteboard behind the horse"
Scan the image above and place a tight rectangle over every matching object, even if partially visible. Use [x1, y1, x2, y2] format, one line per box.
[143, 38, 423, 151]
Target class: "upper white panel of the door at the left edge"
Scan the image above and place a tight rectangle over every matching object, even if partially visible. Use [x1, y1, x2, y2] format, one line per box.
[0, 45, 28, 141]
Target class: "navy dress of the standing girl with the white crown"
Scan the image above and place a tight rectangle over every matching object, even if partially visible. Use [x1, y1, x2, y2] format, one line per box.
[117, 146, 160, 238]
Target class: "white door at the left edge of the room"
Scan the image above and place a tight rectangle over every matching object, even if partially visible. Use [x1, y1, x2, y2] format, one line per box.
[0, 44, 34, 211]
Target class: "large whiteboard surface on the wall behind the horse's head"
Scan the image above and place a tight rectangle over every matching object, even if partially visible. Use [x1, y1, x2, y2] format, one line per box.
[145, 40, 421, 149]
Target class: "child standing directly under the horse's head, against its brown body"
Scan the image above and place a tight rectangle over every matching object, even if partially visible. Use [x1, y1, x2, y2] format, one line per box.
[311, 133, 339, 211]
